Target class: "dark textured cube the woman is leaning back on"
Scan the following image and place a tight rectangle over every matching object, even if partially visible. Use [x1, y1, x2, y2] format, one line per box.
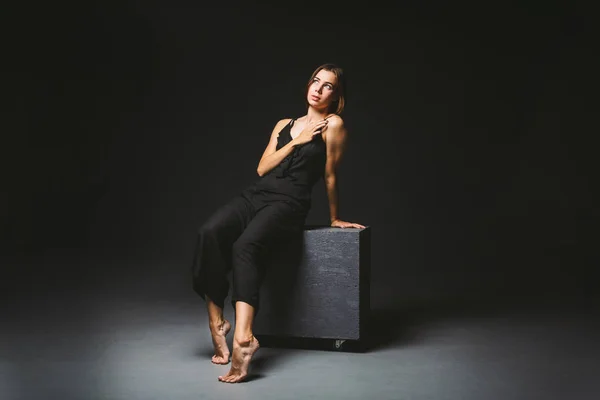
[254, 226, 371, 341]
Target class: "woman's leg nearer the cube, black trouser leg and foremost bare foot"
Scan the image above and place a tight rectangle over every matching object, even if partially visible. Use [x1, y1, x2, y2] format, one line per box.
[219, 202, 305, 383]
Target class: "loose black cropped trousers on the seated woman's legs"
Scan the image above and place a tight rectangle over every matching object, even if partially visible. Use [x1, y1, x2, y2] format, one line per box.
[192, 191, 306, 312]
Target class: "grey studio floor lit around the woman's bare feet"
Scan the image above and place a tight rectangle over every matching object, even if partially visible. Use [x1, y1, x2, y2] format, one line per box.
[0, 253, 600, 400]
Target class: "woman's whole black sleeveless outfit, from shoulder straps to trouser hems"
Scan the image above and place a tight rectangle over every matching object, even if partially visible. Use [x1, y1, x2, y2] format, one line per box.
[192, 119, 326, 312]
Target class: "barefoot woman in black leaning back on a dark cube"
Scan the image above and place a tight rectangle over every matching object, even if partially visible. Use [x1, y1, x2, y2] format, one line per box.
[193, 64, 364, 383]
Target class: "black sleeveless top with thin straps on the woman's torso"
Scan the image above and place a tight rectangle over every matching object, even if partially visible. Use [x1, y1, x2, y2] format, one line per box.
[246, 119, 327, 212]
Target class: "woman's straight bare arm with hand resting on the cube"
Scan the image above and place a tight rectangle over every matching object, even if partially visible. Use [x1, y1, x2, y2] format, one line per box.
[323, 116, 365, 228]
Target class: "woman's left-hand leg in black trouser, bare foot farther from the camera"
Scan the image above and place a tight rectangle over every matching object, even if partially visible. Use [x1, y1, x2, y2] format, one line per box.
[193, 196, 254, 364]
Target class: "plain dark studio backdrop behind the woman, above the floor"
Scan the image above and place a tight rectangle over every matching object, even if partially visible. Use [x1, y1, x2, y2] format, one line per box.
[1, 1, 597, 303]
